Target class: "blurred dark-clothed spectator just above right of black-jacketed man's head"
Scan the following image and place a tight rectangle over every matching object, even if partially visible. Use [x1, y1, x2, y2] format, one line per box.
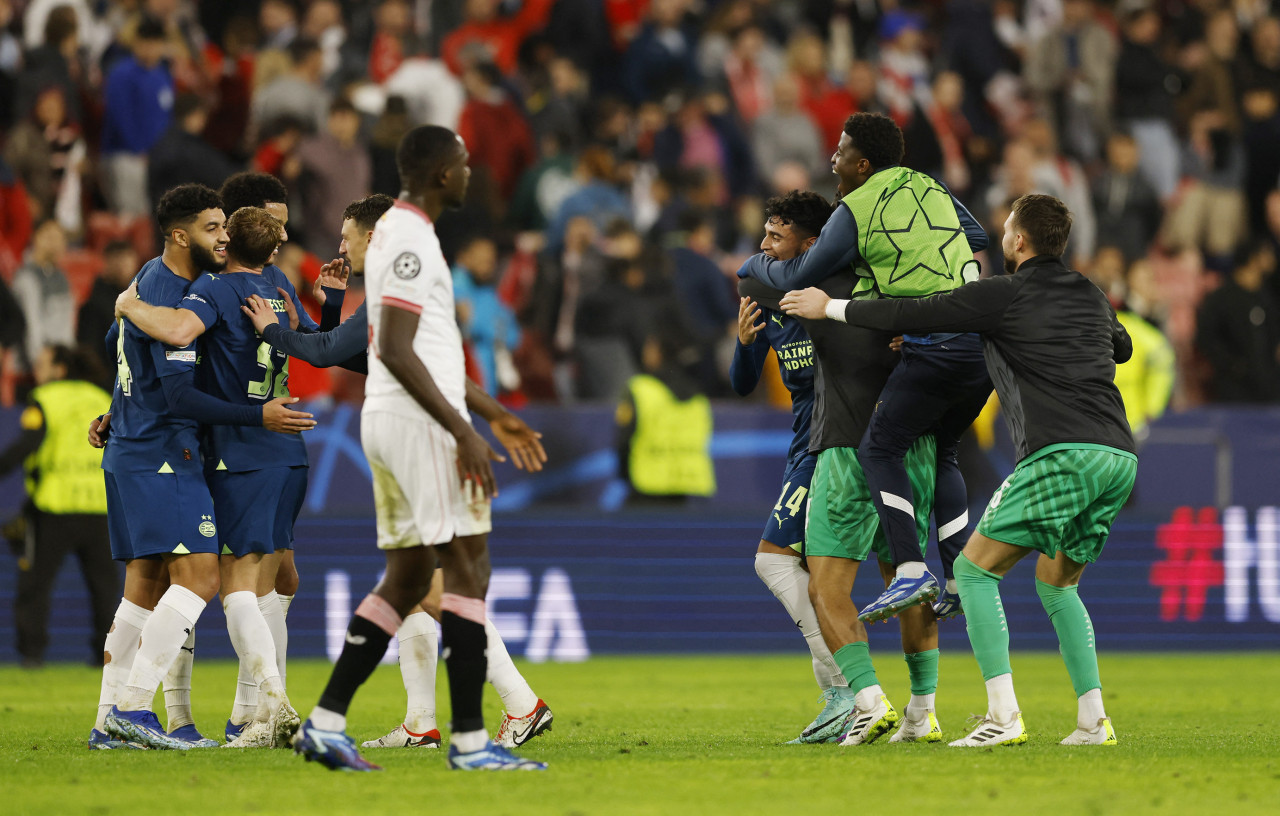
[1093, 130, 1162, 261]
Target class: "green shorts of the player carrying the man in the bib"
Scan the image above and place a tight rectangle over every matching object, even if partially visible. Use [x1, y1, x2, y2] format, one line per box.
[804, 435, 938, 561]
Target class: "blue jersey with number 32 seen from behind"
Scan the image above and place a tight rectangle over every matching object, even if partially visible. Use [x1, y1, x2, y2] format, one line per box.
[182, 266, 319, 472]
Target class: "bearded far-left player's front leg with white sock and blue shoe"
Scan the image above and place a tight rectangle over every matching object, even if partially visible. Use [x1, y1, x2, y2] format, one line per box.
[106, 553, 219, 751]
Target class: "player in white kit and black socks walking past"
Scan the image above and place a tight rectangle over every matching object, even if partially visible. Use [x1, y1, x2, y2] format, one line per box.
[294, 127, 547, 770]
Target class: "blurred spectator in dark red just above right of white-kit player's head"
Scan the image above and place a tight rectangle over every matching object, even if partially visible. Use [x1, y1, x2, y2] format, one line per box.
[458, 63, 536, 214]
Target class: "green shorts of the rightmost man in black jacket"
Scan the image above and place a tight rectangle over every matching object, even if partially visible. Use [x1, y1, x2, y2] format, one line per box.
[978, 444, 1138, 564]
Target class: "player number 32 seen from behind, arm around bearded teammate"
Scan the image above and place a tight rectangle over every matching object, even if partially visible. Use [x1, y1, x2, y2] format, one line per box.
[118, 207, 315, 747]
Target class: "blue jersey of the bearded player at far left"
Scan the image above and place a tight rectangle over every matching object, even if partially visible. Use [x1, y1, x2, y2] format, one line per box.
[102, 258, 201, 473]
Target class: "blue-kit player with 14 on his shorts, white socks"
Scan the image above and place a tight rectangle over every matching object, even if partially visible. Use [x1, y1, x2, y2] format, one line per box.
[728, 191, 854, 743]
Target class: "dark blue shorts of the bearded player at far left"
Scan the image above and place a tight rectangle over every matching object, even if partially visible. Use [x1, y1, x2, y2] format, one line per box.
[102, 471, 218, 561]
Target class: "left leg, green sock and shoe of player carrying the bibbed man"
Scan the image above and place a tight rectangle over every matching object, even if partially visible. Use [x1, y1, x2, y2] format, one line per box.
[808, 555, 899, 746]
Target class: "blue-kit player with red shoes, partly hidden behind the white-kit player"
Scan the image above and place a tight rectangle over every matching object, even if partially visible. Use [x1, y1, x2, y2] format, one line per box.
[243, 194, 552, 748]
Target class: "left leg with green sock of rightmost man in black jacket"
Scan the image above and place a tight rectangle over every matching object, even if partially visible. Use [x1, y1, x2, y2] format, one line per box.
[951, 532, 1032, 747]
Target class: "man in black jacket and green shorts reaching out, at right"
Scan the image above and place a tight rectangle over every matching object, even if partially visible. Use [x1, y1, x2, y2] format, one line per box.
[782, 194, 1137, 747]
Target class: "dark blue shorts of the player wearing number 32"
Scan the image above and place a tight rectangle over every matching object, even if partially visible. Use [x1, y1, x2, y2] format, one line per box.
[206, 466, 307, 558]
